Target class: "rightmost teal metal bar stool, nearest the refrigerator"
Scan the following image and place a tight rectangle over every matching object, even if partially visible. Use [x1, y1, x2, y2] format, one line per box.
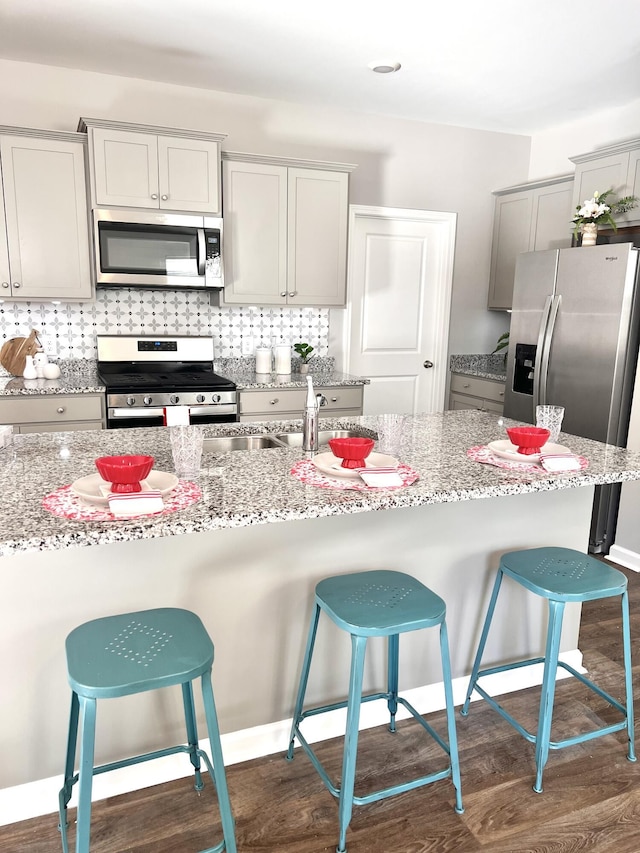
[461, 548, 636, 794]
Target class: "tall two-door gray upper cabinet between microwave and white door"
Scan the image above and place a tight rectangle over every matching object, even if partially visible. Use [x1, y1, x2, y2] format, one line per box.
[222, 152, 355, 305]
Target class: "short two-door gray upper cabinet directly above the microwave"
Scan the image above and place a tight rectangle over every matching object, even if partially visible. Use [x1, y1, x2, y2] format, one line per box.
[79, 118, 225, 215]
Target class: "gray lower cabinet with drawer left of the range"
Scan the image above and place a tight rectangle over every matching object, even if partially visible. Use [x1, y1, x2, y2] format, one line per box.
[0, 394, 105, 433]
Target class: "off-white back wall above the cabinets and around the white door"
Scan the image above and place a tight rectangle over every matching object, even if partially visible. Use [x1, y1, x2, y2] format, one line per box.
[0, 60, 530, 353]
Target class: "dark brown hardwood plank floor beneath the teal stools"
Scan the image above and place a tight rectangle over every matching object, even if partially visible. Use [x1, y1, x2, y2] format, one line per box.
[5, 572, 640, 853]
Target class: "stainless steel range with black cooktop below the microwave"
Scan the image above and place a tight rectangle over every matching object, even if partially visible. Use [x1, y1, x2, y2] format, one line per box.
[98, 335, 238, 429]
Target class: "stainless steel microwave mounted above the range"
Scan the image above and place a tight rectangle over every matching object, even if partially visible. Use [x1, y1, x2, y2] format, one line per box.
[93, 209, 224, 289]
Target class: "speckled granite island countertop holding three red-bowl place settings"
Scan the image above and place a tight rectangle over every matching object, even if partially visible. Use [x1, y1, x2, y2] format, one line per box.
[0, 411, 640, 555]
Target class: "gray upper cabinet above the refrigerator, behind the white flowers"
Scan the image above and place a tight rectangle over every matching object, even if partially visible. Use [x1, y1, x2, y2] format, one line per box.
[570, 139, 640, 226]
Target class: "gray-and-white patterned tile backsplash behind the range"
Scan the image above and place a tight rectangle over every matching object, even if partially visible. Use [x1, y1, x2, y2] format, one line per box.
[0, 288, 329, 359]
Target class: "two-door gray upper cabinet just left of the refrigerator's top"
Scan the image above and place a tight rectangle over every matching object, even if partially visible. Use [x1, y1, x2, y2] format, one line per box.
[488, 175, 573, 311]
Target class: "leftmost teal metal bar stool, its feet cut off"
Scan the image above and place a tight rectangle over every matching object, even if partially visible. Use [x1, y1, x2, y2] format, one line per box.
[59, 607, 237, 853]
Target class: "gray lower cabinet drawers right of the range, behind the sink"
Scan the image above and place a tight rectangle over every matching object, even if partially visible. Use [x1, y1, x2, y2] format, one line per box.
[239, 385, 363, 423]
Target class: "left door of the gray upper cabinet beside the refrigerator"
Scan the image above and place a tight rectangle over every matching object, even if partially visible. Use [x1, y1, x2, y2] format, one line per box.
[488, 190, 533, 310]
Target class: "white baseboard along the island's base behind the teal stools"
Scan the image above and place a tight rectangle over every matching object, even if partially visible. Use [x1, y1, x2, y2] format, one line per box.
[0, 649, 585, 826]
